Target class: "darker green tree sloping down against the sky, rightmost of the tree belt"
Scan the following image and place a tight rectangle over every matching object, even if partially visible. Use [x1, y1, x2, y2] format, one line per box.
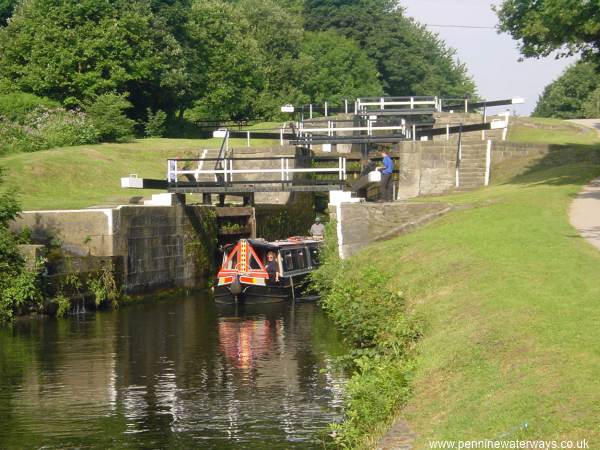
[304, 0, 475, 97]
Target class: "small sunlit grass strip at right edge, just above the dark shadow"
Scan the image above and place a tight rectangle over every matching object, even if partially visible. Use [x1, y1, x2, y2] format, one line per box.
[508, 117, 600, 145]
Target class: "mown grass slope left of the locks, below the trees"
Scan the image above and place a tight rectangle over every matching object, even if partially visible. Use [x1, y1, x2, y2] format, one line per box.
[0, 139, 272, 210]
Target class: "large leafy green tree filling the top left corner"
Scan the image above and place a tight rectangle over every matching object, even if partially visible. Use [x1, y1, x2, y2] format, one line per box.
[0, 0, 181, 117]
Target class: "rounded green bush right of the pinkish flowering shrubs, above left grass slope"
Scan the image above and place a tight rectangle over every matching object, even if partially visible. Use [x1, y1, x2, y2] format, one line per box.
[87, 93, 135, 142]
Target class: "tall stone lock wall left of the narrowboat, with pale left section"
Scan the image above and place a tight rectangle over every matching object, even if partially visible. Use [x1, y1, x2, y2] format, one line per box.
[11, 205, 217, 293]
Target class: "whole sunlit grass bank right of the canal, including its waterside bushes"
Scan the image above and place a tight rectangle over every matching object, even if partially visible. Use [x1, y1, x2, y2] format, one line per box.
[324, 125, 600, 449]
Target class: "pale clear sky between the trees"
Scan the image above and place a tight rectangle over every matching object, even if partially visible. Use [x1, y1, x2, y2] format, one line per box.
[400, 0, 576, 116]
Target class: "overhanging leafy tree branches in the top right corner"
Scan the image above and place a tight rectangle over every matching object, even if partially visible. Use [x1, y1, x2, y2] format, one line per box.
[496, 0, 600, 57]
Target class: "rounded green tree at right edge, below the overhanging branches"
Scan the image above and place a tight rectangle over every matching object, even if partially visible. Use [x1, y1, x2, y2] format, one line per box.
[533, 61, 600, 119]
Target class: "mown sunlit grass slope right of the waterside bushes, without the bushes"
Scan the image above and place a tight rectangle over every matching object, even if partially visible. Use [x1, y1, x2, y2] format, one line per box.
[386, 153, 600, 448]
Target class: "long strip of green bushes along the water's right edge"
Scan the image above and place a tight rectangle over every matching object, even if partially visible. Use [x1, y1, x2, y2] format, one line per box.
[311, 223, 420, 448]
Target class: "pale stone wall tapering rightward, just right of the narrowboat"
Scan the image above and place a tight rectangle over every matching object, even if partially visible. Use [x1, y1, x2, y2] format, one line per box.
[330, 202, 451, 258]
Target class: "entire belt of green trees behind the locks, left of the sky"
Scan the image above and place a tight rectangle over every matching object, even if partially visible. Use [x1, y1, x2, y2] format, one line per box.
[0, 0, 474, 123]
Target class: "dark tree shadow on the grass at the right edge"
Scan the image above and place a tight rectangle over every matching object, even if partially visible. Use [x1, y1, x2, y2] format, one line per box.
[506, 144, 600, 186]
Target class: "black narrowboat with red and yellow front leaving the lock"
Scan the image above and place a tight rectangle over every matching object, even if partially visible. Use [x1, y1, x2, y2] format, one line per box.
[214, 237, 322, 304]
